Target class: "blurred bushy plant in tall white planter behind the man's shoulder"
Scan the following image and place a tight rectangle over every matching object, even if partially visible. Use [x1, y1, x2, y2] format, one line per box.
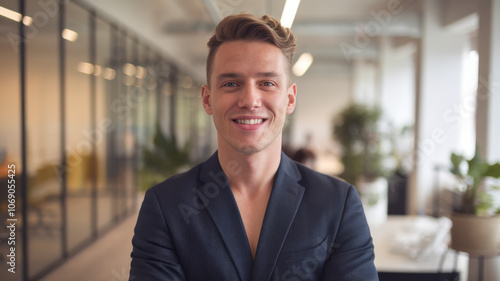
[333, 104, 388, 225]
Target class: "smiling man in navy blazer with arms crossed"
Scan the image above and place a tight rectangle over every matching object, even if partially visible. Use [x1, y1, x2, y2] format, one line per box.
[130, 14, 378, 281]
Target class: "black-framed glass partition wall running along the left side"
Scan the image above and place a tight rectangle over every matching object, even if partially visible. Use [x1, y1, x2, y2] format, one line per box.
[0, 0, 213, 281]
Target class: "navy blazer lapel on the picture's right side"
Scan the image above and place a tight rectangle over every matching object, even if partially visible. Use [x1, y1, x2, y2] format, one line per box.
[252, 153, 305, 281]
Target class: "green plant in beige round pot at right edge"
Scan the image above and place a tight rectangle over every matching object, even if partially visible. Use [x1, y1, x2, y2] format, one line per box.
[451, 147, 500, 255]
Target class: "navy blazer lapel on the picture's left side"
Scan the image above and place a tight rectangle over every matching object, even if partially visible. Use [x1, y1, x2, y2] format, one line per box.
[198, 152, 253, 281]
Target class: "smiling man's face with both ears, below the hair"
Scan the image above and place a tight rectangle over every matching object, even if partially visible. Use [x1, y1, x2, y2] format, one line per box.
[202, 41, 296, 154]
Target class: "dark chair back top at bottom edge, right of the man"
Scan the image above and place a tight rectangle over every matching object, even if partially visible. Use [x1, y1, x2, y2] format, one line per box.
[378, 271, 460, 281]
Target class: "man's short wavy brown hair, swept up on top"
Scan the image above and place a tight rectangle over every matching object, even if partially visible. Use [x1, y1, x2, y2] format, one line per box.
[206, 13, 296, 86]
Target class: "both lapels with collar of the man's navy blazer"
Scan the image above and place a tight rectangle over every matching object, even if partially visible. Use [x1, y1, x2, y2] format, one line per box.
[198, 152, 304, 281]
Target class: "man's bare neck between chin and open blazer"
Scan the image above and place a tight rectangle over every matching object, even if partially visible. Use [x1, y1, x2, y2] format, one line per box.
[218, 138, 281, 194]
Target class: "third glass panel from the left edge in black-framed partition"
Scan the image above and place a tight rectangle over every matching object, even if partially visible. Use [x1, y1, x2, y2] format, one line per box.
[63, 2, 95, 251]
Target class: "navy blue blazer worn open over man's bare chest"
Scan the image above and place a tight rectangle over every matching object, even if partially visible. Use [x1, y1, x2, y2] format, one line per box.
[130, 152, 378, 281]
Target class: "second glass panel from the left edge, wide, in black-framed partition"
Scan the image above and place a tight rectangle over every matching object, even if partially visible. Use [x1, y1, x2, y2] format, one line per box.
[26, 1, 62, 276]
